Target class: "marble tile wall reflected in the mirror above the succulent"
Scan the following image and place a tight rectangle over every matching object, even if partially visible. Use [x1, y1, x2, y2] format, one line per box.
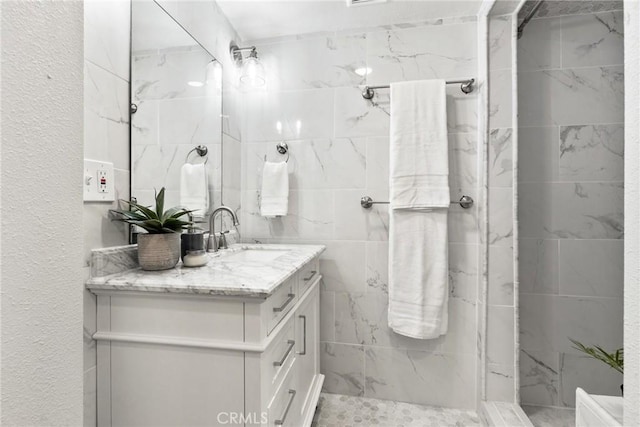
[131, 46, 222, 216]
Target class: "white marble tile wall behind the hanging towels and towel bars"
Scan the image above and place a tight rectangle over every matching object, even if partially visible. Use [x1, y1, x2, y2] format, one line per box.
[240, 19, 478, 408]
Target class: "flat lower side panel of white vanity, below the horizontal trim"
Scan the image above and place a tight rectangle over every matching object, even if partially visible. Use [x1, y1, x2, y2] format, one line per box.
[110, 342, 244, 427]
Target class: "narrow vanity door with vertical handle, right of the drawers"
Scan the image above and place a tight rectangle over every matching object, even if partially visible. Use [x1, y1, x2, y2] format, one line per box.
[296, 283, 320, 420]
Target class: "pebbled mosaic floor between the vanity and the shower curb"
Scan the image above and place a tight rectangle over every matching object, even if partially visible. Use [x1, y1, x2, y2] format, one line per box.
[311, 393, 482, 427]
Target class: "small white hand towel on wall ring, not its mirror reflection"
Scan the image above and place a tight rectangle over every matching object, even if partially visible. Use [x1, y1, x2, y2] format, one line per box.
[260, 162, 289, 217]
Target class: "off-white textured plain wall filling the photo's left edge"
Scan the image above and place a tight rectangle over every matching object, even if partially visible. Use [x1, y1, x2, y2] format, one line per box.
[1, 1, 83, 426]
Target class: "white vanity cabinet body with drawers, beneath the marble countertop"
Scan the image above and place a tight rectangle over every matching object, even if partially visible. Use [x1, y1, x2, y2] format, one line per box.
[92, 251, 324, 427]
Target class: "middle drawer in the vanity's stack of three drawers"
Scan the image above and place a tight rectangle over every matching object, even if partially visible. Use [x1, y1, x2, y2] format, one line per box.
[260, 317, 298, 398]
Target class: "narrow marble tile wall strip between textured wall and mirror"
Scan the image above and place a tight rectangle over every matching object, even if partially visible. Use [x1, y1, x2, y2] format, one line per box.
[78, 0, 130, 426]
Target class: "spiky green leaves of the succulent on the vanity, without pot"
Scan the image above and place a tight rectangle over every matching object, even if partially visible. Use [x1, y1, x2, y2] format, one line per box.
[111, 187, 192, 234]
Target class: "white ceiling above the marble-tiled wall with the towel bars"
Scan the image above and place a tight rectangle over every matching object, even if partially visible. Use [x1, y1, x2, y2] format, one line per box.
[217, 0, 482, 42]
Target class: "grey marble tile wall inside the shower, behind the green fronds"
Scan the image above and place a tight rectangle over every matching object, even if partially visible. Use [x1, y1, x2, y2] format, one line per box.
[518, 11, 624, 407]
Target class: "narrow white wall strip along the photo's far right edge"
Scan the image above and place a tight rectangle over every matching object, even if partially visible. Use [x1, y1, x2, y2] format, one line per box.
[624, 0, 640, 426]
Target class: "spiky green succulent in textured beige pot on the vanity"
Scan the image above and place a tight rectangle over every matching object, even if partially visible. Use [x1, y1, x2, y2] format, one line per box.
[112, 187, 192, 270]
